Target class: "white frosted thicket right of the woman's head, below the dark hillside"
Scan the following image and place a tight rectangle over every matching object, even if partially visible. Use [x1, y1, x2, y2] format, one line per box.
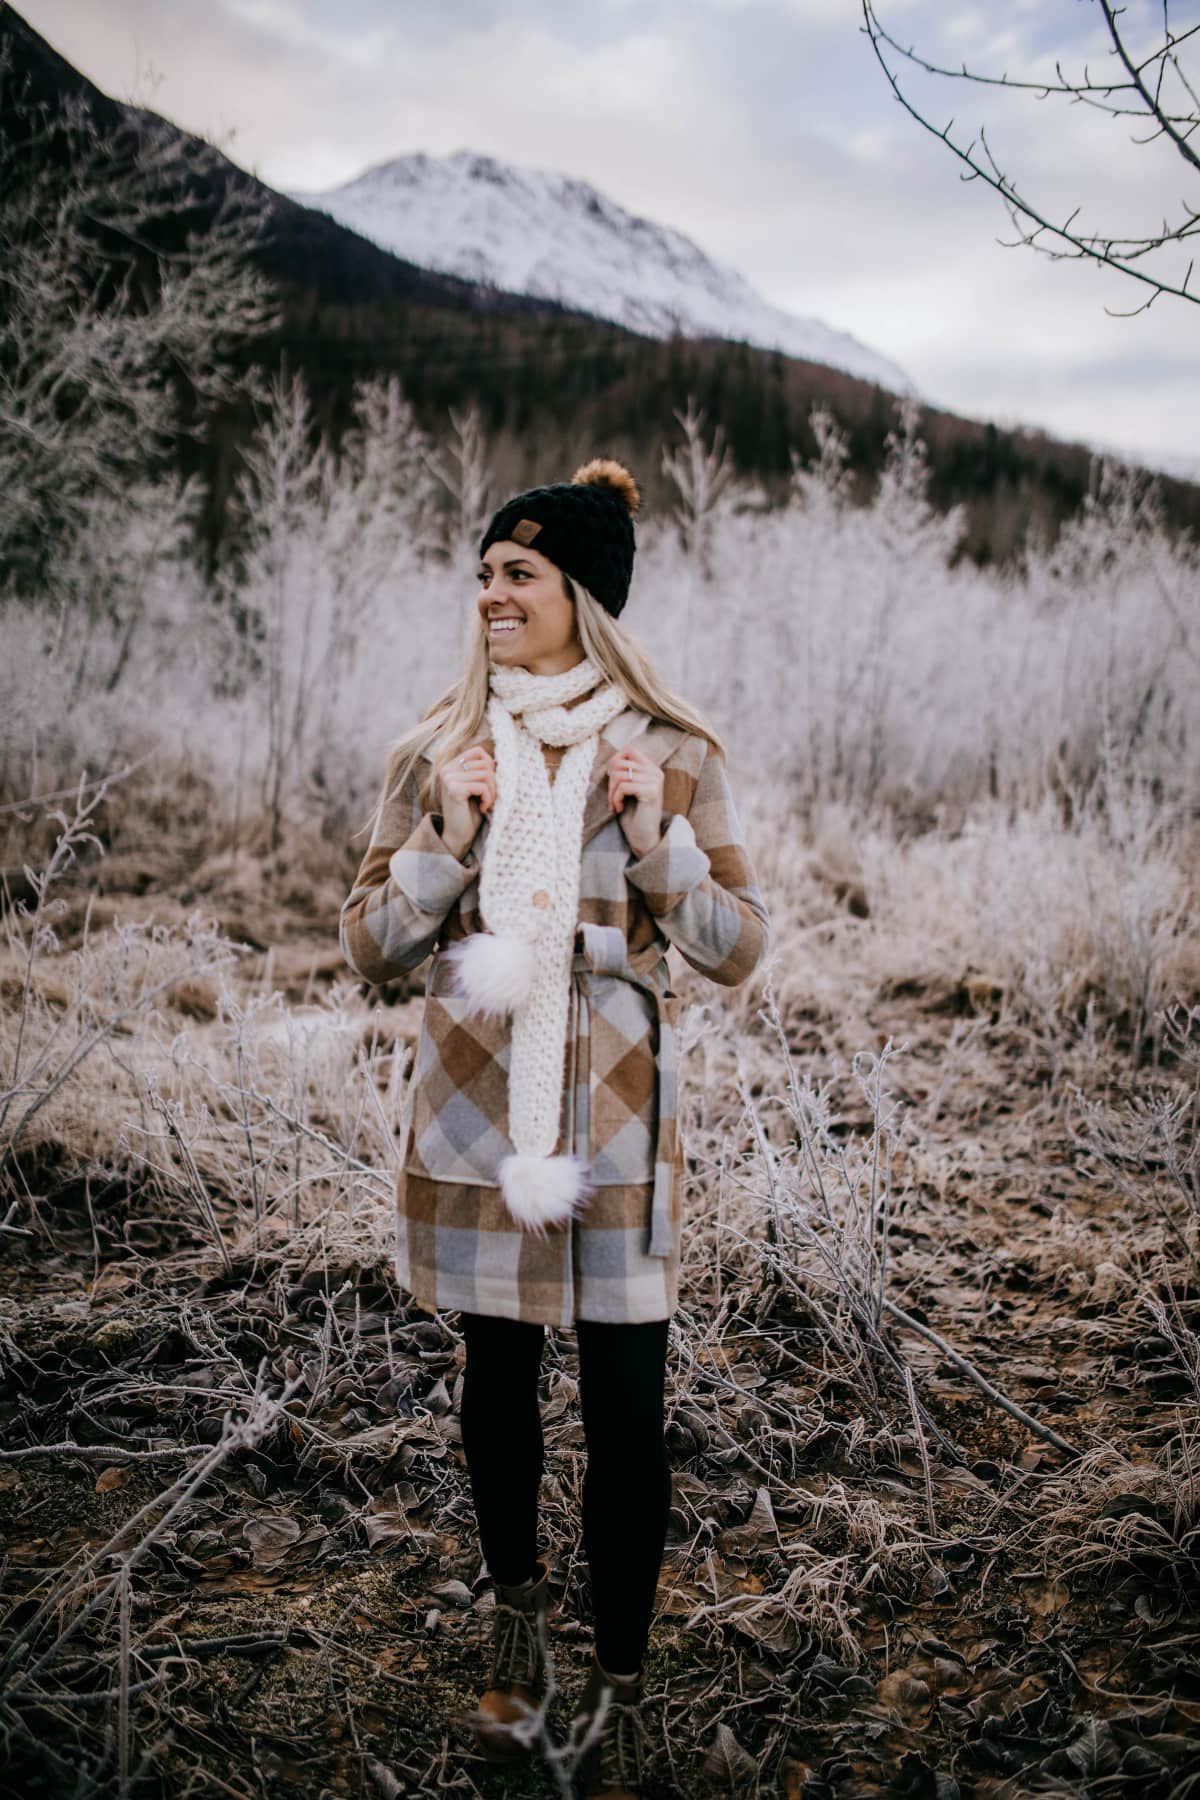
[630, 410, 1200, 826]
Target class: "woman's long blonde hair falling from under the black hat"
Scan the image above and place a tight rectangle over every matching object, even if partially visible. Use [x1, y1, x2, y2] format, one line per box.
[363, 571, 725, 830]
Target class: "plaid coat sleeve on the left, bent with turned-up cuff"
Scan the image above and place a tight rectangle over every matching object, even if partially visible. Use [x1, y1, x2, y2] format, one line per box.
[338, 752, 479, 983]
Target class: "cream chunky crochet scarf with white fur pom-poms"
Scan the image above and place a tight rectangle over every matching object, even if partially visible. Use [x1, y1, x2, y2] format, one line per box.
[448, 657, 626, 1237]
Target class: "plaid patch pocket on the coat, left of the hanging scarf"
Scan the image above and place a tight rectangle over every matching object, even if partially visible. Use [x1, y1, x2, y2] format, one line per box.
[405, 959, 513, 1186]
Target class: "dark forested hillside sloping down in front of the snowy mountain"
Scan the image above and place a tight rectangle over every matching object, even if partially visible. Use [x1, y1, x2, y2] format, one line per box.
[0, 7, 1200, 563]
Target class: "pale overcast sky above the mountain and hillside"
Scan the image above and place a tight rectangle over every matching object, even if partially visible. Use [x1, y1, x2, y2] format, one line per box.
[16, 0, 1200, 464]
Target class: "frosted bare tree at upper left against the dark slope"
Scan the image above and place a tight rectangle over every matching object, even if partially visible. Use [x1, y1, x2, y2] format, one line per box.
[0, 52, 277, 596]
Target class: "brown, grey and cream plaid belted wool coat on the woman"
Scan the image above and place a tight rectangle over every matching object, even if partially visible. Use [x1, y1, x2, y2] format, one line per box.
[340, 706, 768, 1327]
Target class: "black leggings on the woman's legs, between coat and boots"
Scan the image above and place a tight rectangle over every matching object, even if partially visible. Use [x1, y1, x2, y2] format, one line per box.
[459, 1312, 671, 1674]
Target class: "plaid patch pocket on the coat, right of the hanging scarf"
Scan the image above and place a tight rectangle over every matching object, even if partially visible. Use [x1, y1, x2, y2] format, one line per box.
[581, 974, 658, 1186]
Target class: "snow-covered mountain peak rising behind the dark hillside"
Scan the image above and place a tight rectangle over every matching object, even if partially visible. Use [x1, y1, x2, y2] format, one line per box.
[290, 149, 914, 392]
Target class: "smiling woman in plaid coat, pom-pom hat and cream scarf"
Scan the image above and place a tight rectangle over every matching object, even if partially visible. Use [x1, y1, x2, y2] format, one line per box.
[342, 459, 766, 1796]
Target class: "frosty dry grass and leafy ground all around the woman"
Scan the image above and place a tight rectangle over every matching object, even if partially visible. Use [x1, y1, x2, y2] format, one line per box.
[0, 770, 1200, 1800]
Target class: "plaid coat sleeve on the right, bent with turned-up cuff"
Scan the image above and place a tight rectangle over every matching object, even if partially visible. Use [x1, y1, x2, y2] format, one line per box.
[626, 745, 770, 988]
